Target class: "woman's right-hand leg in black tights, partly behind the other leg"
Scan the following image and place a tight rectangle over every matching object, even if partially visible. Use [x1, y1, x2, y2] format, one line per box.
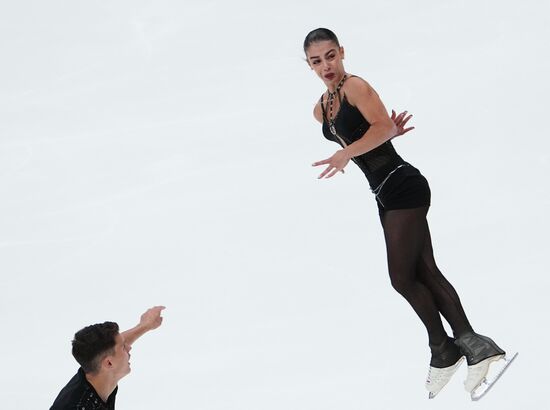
[417, 221, 473, 338]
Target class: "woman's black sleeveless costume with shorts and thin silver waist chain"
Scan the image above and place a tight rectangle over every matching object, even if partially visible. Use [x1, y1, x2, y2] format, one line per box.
[320, 84, 430, 213]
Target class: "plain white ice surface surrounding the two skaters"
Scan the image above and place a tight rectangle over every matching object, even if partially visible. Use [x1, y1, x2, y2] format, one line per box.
[0, 0, 550, 410]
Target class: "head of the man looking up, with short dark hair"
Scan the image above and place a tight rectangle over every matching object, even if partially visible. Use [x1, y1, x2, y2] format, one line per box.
[72, 322, 131, 379]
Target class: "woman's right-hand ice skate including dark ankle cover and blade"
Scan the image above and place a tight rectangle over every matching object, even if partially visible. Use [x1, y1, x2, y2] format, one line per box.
[455, 332, 517, 400]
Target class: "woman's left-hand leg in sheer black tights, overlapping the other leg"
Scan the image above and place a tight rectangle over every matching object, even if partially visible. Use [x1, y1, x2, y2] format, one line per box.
[380, 206, 447, 346]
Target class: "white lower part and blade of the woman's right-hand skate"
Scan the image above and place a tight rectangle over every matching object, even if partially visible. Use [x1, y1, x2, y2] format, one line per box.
[464, 353, 518, 401]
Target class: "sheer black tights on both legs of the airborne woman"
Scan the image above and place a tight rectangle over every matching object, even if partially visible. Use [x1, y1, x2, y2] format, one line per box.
[380, 206, 472, 345]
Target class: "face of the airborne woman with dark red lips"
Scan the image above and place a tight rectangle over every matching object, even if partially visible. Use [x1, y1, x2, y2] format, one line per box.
[306, 40, 345, 87]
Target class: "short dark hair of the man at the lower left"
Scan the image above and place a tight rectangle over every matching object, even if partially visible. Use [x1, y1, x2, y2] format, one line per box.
[72, 322, 119, 373]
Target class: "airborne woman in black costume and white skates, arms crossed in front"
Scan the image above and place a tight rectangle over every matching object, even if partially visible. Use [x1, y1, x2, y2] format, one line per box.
[304, 28, 509, 398]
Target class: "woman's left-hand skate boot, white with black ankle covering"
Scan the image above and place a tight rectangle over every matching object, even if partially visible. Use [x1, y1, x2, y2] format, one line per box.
[426, 337, 464, 399]
